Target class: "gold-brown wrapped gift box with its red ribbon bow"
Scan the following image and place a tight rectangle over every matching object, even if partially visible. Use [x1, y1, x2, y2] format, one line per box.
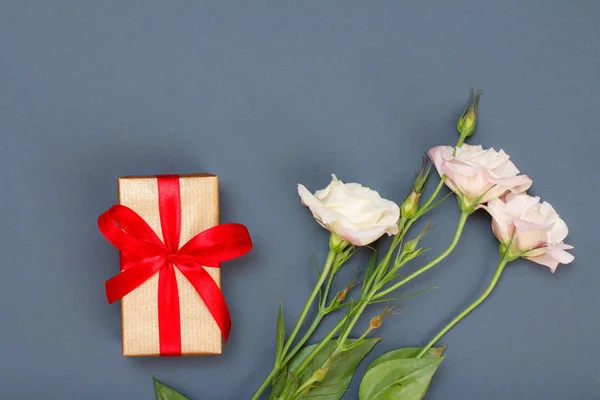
[98, 174, 251, 356]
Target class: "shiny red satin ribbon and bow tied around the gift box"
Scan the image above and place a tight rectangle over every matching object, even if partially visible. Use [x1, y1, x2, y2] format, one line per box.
[98, 175, 252, 356]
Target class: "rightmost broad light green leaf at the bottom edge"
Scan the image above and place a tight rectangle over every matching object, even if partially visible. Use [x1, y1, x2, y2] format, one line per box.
[358, 347, 446, 400]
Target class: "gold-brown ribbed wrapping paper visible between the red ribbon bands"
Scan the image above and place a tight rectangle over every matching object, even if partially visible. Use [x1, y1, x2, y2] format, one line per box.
[119, 174, 222, 356]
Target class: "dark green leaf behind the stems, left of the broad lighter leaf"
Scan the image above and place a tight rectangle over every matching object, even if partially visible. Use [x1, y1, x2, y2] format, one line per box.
[289, 338, 380, 400]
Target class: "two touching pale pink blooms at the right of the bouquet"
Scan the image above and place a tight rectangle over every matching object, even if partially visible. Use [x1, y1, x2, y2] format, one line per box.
[429, 144, 573, 272]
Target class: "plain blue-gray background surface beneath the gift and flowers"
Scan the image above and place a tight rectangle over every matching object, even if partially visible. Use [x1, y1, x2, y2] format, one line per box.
[0, 0, 600, 400]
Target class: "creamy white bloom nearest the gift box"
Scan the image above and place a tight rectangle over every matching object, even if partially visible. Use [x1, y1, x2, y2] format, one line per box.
[298, 175, 400, 246]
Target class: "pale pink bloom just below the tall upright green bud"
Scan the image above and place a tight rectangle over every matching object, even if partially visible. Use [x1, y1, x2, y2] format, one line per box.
[429, 144, 532, 206]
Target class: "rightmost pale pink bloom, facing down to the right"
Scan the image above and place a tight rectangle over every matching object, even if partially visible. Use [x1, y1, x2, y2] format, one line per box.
[479, 194, 574, 272]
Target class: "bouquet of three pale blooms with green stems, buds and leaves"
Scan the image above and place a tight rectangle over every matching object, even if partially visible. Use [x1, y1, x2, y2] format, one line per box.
[155, 90, 573, 400]
